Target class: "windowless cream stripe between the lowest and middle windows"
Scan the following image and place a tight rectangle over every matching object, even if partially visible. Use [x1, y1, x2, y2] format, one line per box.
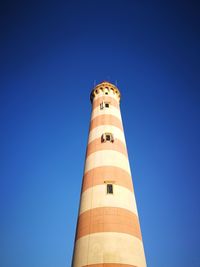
[85, 150, 131, 175]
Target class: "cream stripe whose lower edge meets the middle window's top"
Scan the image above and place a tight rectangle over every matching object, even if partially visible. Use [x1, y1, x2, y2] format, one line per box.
[88, 125, 126, 146]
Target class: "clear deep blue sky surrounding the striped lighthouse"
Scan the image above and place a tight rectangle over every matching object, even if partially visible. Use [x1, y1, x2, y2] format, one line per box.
[0, 0, 200, 267]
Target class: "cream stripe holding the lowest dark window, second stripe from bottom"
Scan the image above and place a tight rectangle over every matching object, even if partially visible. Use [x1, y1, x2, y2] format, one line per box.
[79, 185, 138, 215]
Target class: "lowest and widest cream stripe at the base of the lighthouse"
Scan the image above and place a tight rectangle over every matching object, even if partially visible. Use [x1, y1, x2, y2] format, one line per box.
[73, 232, 146, 267]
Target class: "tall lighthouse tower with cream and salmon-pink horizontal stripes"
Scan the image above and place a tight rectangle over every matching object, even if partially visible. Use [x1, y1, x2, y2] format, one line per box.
[72, 82, 146, 267]
